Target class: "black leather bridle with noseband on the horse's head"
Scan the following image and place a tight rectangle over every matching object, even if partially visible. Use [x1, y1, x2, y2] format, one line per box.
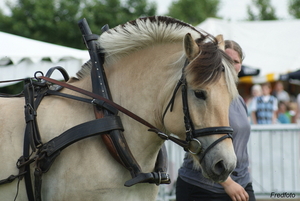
[163, 60, 233, 163]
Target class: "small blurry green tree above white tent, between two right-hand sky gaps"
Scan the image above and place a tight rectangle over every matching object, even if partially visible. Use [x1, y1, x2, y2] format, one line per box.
[247, 0, 278, 21]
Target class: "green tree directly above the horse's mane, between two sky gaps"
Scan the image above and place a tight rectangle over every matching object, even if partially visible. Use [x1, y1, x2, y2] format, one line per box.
[168, 0, 220, 25]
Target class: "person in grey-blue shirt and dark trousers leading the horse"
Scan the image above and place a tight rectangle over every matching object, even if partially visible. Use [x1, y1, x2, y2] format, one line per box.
[176, 40, 256, 201]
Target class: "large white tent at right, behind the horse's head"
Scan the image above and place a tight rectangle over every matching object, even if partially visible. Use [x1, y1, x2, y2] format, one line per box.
[197, 18, 300, 83]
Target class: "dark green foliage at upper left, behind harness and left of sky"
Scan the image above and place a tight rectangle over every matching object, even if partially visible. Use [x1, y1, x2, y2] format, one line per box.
[0, 0, 156, 48]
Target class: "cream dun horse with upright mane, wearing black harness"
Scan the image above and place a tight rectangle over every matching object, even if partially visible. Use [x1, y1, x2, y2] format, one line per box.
[0, 16, 237, 201]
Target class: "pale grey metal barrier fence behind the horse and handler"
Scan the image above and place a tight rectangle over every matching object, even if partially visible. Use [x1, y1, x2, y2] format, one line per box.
[157, 124, 300, 201]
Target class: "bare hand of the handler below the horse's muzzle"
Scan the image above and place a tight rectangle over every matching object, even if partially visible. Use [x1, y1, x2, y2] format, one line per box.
[220, 177, 249, 201]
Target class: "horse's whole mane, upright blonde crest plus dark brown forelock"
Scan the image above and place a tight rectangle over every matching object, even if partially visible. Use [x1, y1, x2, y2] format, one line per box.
[77, 16, 238, 97]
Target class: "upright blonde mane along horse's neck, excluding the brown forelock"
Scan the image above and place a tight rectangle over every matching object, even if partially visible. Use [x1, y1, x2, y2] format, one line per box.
[77, 16, 208, 78]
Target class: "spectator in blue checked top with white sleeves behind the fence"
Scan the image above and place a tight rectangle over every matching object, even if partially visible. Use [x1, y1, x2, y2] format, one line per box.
[251, 83, 278, 124]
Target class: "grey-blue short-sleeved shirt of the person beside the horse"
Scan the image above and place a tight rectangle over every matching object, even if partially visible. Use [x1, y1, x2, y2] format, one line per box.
[178, 96, 251, 193]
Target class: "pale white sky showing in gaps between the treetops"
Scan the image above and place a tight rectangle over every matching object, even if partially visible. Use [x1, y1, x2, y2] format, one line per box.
[149, 0, 291, 21]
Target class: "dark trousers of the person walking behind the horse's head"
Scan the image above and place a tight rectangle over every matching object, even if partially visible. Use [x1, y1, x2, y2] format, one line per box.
[176, 177, 256, 201]
